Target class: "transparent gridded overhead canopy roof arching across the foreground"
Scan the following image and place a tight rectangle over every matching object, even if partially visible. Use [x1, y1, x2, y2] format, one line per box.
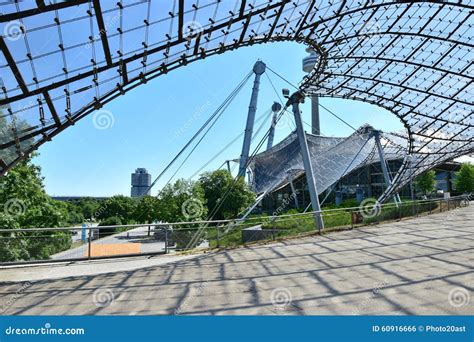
[0, 0, 474, 200]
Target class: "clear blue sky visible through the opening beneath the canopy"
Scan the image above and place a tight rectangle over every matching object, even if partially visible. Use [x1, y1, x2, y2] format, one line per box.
[34, 43, 403, 196]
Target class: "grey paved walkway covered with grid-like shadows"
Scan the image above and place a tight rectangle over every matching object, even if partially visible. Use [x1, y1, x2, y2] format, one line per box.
[0, 206, 474, 315]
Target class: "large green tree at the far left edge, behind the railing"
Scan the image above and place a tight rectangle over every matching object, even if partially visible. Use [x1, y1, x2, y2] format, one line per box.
[0, 160, 72, 261]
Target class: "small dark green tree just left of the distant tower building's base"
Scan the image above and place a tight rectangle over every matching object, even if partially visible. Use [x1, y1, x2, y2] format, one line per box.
[96, 195, 137, 224]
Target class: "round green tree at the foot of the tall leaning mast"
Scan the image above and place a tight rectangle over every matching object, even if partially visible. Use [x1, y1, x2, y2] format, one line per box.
[199, 170, 255, 220]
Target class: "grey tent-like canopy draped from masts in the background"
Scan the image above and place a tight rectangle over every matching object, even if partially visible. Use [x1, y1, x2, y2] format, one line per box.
[249, 125, 406, 194]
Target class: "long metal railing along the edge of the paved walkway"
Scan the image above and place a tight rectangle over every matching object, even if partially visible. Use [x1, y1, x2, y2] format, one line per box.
[0, 195, 471, 265]
